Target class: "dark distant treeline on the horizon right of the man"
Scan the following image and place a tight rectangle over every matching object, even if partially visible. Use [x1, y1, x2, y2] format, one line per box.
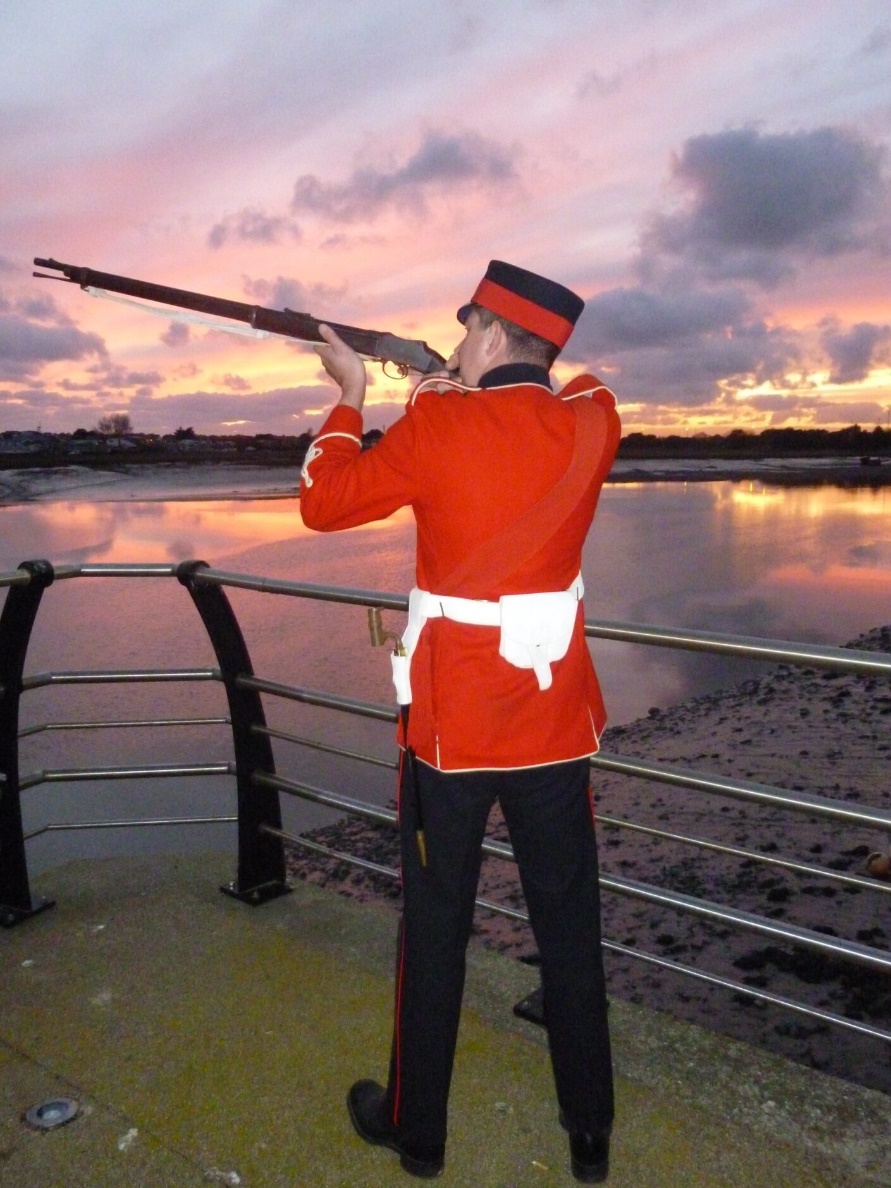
[619, 425, 891, 459]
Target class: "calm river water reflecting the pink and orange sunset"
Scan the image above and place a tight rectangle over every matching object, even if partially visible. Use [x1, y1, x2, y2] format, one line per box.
[0, 482, 891, 867]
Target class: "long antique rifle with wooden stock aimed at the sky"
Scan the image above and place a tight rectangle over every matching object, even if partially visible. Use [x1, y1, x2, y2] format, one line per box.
[33, 257, 446, 379]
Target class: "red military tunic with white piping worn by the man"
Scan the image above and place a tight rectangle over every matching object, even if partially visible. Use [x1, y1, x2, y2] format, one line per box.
[301, 375, 620, 771]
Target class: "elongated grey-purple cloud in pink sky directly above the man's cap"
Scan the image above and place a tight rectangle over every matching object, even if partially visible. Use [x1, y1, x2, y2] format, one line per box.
[291, 132, 517, 223]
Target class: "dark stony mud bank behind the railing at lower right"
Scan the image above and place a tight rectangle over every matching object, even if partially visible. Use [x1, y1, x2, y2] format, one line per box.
[290, 627, 891, 1092]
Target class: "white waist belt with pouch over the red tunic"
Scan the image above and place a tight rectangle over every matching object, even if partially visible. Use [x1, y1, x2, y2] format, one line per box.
[392, 574, 584, 706]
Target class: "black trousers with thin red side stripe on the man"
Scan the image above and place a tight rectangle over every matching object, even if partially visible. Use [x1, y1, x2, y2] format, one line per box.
[387, 759, 613, 1148]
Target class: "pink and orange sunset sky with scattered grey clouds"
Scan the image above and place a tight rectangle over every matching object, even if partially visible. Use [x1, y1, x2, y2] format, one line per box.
[0, 0, 891, 434]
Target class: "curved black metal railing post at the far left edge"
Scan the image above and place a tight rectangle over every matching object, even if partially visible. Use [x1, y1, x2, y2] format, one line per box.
[0, 561, 56, 928]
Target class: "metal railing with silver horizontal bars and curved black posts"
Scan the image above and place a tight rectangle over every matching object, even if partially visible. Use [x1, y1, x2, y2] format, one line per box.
[0, 561, 891, 1041]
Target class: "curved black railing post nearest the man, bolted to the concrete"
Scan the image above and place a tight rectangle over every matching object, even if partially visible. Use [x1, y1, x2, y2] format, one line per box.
[176, 561, 291, 904]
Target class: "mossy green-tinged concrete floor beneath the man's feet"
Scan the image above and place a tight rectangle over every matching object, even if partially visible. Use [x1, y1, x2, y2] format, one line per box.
[0, 855, 891, 1188]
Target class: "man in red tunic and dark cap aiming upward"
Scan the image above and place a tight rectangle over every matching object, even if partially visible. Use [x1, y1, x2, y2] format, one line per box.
[301, 260, 620, 1183]
